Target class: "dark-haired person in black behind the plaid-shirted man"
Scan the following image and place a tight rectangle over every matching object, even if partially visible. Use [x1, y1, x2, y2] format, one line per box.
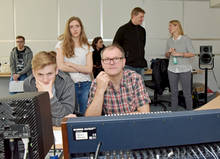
[92, 36, 105, 78]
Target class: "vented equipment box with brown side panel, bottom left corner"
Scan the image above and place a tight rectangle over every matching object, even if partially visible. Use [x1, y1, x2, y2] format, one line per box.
[0, 92, 54, 159]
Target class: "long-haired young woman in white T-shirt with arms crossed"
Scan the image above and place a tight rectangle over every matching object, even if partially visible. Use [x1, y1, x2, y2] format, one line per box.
[56, 17, 93, 114]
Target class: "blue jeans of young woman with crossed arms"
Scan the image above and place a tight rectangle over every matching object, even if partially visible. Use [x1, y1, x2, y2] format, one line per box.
[75, 81, 92, 115]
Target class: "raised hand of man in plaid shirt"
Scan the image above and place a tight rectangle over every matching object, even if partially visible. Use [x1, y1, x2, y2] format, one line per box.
[96, 71, 110, 92]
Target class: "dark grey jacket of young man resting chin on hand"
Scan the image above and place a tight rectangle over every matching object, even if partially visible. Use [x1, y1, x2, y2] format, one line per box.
[24, 71, 75, 126]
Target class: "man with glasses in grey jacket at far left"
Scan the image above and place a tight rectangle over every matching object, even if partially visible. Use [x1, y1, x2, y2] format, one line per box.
[10, 36, 33, 94]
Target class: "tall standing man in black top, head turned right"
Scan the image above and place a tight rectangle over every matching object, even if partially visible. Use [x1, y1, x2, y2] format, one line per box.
[113, 7, 147, 77]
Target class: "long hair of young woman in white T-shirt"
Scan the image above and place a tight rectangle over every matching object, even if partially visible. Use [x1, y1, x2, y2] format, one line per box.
[58, 16, 89, 58]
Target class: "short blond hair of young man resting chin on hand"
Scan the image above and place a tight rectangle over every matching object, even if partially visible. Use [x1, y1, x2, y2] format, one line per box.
[32, 51, 57, 71]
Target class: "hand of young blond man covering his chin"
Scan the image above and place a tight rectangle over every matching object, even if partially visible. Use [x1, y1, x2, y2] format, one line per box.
[36, 80, 54, 98]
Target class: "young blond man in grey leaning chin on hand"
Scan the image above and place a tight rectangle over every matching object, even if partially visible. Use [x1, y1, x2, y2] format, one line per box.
[24, 51, 76, 126]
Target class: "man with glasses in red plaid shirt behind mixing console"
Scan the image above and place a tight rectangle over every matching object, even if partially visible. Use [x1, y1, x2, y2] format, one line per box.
[85, 44, 150, 116]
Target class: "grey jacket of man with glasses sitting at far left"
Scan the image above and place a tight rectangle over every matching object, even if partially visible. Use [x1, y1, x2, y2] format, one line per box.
[10, 46, 33, 76]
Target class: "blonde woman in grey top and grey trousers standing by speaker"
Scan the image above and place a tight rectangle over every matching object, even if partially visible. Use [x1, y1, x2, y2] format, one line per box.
[165, 20, 194, 110]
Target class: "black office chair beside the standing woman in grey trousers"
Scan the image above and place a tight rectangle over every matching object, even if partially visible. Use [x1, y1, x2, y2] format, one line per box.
[144, 58, 171, 111]
